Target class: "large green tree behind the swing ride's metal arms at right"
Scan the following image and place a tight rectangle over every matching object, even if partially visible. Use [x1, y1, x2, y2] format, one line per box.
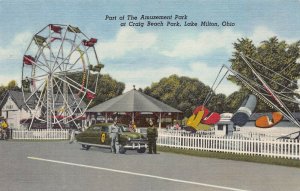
[226, 37, 300, 112]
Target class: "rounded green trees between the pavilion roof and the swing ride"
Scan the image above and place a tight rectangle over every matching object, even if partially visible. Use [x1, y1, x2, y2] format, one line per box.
[144, 75, 226, 117]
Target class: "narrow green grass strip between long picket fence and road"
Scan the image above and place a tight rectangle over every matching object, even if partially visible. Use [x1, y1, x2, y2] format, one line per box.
[158, 146, 300, 168]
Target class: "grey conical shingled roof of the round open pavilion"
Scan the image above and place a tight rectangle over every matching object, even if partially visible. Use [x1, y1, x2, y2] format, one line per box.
[87, 89, 181, 113]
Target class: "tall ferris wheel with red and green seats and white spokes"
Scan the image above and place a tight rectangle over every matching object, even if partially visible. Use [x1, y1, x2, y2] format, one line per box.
[22, 24, 103, 129]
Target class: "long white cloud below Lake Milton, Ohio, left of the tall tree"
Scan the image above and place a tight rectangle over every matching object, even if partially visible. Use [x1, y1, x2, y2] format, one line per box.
[162, 29, 242, 58]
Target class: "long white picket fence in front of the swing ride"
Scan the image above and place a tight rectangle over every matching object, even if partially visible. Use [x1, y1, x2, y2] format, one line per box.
[157, 130, 300, 160]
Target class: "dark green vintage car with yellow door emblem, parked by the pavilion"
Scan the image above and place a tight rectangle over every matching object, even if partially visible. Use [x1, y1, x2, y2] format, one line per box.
[76, 123, 147, 154]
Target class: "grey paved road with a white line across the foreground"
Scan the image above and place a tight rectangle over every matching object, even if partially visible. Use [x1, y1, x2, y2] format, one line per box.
[0, 141, 300, 191]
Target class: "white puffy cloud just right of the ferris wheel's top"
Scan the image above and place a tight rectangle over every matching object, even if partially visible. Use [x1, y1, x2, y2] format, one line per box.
[97, 27, 157, 59]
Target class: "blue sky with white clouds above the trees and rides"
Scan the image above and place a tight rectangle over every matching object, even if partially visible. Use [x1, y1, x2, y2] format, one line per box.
[0, 0, 300, 95]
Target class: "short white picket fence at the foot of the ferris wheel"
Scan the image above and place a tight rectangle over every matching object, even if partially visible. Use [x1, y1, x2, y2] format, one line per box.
[11, 129, 69, 140]
